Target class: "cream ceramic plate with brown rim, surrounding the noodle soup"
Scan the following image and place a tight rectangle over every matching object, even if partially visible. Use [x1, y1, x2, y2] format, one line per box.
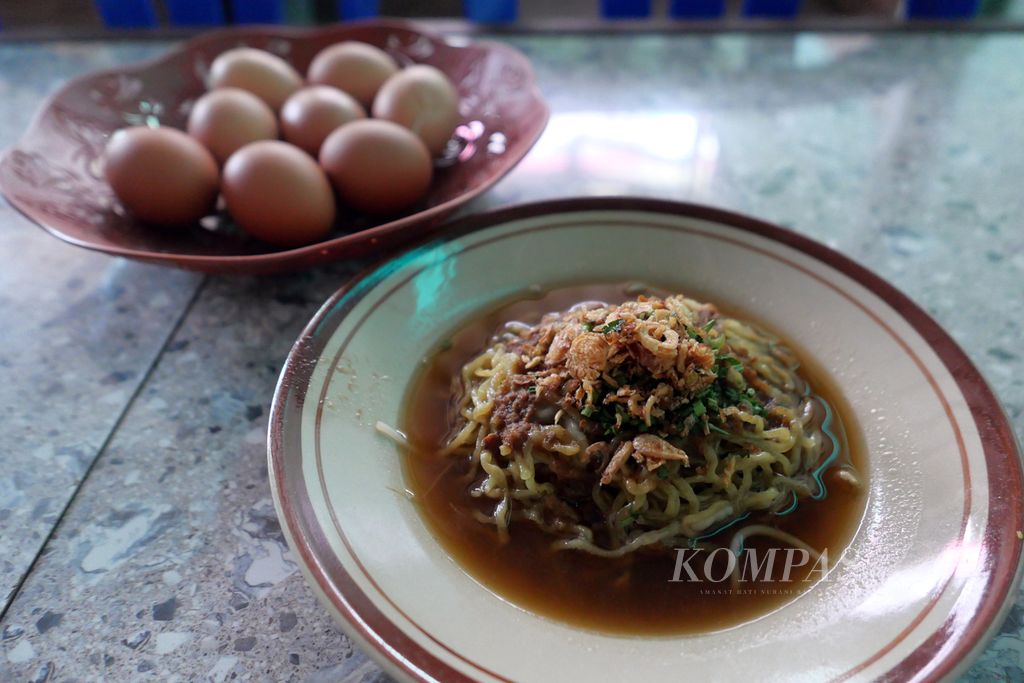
[270, 200, 1021, 681]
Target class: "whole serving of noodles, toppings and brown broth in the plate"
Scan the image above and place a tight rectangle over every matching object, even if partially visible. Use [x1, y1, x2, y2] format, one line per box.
[400, 285, 864, 634]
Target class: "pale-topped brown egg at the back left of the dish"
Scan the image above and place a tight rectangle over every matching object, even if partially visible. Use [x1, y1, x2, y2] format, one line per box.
[209, 47, 302, 112]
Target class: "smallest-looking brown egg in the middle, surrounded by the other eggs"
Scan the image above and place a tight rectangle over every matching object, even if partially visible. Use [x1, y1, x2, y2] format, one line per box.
[281, 85, 367, 157]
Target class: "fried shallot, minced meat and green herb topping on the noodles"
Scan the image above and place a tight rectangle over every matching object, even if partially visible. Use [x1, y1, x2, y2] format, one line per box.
[487, 296, 767, 483]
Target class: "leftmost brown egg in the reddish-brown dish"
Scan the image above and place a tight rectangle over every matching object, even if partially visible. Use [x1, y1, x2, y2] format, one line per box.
[103, 126, 219, 225]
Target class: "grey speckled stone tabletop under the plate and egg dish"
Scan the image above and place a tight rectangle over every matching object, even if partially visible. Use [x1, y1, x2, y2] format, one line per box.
[0, 29, 1024, 682]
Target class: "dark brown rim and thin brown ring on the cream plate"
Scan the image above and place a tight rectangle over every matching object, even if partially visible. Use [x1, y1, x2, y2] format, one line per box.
[270, 198, 1022, 679]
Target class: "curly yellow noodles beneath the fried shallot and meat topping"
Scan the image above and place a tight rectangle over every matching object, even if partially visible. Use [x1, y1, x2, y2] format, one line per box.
[445, 297, 859, 557]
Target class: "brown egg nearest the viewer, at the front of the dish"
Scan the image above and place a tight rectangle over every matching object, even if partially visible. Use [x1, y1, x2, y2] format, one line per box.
[220, 140, 335, 247]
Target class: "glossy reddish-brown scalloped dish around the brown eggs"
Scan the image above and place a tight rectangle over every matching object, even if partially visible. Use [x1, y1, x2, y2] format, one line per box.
[0, 22, 548, 272]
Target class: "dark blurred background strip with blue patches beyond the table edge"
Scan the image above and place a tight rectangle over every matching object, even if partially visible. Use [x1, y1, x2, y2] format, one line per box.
[0, 0, 1024, 39]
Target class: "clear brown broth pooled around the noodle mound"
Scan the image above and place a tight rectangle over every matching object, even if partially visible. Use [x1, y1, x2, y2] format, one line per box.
[401, 284, 865, 635]
